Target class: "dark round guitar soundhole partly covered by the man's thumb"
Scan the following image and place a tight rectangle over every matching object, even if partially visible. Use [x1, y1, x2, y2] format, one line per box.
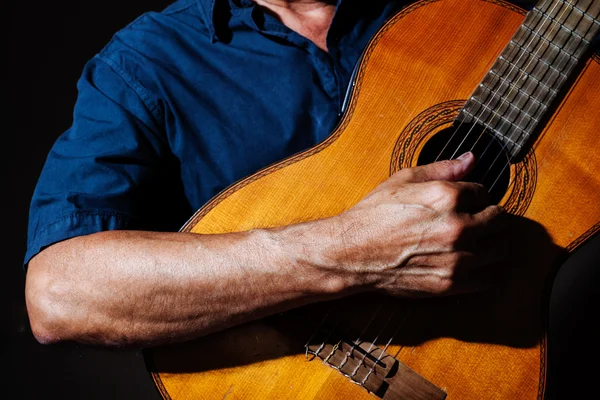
[417, 124, 510, 204]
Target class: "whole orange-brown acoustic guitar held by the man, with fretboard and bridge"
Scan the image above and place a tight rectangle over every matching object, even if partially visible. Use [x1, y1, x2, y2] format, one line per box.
[144, 0, 600, 400]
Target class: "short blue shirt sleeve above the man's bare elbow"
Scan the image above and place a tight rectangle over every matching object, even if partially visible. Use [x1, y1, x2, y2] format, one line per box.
[24, 56, 182, 266]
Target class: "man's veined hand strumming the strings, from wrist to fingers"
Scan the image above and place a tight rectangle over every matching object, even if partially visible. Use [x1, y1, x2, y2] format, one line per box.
[332, 153, 507, 297]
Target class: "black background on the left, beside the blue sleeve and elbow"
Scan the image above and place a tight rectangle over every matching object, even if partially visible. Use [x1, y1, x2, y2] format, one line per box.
[0, 0, 170, 399]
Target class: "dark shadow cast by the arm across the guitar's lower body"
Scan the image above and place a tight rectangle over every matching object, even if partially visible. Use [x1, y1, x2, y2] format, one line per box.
[145, 215, 567, 373]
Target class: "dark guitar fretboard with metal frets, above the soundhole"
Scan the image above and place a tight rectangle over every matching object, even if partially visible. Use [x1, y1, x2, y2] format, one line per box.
[459, 0, 600, 157]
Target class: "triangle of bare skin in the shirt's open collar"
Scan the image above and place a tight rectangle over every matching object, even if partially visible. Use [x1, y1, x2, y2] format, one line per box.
[254, 0, 337, 51]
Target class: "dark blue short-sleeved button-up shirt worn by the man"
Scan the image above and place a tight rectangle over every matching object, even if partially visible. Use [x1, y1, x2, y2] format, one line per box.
[25, 0, 403, 264]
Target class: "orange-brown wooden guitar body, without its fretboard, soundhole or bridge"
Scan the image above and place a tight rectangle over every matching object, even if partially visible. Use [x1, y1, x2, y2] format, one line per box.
[145, 0, 600, 400]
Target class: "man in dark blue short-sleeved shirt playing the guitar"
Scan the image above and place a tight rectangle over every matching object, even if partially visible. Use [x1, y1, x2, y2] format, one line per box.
[25, 0, 524, 346]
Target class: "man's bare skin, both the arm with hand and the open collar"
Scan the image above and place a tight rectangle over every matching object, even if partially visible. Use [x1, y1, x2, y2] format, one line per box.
[25, 0, 506, 347]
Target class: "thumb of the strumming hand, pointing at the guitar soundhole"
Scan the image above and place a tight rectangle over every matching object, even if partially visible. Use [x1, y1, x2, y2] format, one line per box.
[398, 152, 475, 183]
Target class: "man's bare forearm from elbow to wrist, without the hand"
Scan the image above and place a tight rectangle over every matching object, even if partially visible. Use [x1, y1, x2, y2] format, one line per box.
[26, 223, 353, 346]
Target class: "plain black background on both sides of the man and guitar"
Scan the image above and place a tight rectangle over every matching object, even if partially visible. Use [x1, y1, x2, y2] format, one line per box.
[0, 0, 600, 400]
